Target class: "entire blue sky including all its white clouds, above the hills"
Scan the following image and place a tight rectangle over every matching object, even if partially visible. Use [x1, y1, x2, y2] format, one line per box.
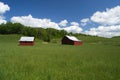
[0, 0, 120, 37]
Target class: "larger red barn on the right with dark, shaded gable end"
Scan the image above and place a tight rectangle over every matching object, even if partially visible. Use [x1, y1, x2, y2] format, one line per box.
[62, 35, 83, 45]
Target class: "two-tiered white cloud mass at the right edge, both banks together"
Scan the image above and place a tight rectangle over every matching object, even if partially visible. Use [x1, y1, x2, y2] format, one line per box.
[83, 6, 120, 38]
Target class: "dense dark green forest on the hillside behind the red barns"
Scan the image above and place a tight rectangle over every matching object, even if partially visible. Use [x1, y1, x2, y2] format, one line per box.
[0, 22, 82, 42]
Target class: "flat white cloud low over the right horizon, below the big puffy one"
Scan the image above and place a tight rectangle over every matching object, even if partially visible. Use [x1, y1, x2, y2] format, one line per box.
[85, 25, 120, 38]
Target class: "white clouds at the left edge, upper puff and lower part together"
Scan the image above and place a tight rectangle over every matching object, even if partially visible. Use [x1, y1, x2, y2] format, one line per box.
[0, 2, 10, 24]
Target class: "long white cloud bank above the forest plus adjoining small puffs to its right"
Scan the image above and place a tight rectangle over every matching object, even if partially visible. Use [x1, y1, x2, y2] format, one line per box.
[11, 15, 82, 33]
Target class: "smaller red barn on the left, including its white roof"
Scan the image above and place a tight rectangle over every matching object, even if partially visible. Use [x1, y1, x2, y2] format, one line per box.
[19, 37, 34, 46]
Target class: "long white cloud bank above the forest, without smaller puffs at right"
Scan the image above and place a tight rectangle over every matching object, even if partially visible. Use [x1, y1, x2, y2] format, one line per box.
[11, 15, 60, 30]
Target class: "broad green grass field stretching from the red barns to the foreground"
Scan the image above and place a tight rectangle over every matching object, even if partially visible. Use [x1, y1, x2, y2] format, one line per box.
[0, 35, 120, 80]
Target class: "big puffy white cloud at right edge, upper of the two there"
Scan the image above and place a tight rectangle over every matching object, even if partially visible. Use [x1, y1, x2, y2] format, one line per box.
[91, 6, 120, 25]
